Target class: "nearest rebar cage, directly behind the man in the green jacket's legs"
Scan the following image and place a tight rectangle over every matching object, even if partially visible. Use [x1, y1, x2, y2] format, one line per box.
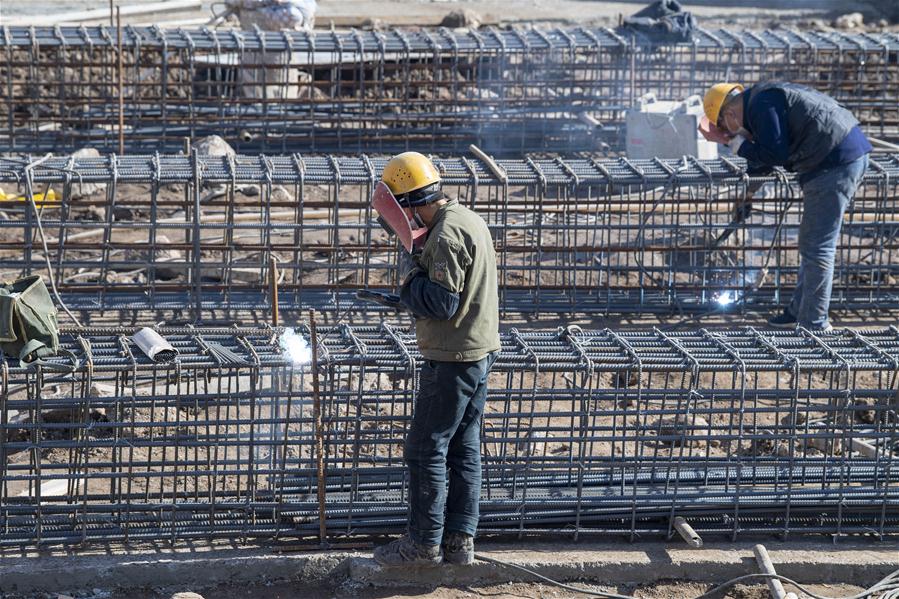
[0, 325, 899, 545]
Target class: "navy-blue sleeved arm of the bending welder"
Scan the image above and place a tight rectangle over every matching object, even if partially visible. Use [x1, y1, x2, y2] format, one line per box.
[730, 90, 790, 166]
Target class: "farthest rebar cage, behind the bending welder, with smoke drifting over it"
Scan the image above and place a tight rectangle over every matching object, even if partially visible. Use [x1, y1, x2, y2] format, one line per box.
[0, 27, 899, 156]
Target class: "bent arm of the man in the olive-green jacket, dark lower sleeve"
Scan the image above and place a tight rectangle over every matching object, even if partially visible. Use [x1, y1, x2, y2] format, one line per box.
[400, 238, 471, 320]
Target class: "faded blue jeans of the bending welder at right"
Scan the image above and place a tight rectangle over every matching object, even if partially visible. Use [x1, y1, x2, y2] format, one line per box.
[789, 154, 868, 330]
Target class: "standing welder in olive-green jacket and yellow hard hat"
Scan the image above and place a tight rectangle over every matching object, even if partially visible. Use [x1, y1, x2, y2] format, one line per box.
[374, 152, 500, 566]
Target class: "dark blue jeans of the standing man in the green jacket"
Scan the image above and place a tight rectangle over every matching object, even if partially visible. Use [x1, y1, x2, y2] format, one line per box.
[404, 353, 496, 545]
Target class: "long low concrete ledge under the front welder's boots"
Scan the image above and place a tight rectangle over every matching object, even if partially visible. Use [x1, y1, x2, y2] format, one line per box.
[0, 539, 899, 594]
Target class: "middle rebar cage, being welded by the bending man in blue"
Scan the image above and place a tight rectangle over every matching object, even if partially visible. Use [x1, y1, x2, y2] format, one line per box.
[0, 155, 899, 322]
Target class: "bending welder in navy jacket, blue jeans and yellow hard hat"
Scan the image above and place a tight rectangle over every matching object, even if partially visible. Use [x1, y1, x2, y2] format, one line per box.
[700, 82, 872, 332]
